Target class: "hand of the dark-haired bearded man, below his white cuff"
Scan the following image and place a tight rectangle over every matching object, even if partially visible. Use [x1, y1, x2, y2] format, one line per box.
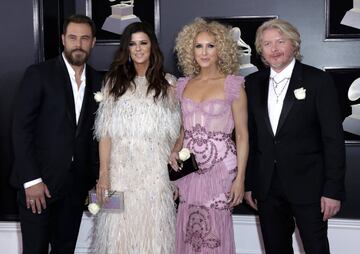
[25, 182, 51, 214]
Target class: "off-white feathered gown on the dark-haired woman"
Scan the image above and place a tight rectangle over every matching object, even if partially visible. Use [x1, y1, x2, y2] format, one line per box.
[92, 75, 181, 254]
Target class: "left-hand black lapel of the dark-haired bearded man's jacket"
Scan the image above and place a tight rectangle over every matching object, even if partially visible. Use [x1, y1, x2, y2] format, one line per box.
[58, 55, 76, 129]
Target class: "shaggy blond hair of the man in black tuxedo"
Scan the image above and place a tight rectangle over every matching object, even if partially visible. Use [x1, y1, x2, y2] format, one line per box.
[255, 19, 302, 65]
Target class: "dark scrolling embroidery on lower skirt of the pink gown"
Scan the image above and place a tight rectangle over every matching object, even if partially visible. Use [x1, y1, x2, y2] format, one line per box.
[185, 205, 221, 252]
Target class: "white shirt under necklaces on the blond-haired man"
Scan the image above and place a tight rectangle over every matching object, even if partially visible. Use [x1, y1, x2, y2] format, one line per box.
[268, 59, 295, 134]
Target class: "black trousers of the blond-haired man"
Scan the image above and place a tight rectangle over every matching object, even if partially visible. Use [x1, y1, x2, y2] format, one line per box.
[258, 173, 330, 254]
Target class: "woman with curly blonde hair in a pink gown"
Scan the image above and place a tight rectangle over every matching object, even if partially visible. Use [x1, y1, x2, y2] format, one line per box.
[170, 19, 248, 254]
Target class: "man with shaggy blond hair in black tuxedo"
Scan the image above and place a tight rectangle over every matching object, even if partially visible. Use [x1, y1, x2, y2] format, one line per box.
[245, 19, 345, 254]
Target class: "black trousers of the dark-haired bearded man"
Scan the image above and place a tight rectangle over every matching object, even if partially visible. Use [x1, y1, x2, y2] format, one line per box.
[18, 172, 87, 254]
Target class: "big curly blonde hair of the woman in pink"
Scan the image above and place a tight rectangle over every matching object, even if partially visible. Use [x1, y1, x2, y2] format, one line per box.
[174, 18, 240, 76]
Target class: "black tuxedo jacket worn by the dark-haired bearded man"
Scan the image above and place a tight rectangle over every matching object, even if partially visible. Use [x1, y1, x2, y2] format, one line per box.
[11, 55, 101, 197]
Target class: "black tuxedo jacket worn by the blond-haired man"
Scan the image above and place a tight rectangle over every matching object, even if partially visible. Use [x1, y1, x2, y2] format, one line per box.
[246, 62, 345, 204]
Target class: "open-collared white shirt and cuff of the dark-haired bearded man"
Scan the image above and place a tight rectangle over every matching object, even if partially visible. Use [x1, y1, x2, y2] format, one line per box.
[24, 53, 86, 189]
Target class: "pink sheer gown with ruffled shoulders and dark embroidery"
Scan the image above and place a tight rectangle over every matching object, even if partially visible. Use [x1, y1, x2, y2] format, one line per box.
[175, 75, 244, 254]
